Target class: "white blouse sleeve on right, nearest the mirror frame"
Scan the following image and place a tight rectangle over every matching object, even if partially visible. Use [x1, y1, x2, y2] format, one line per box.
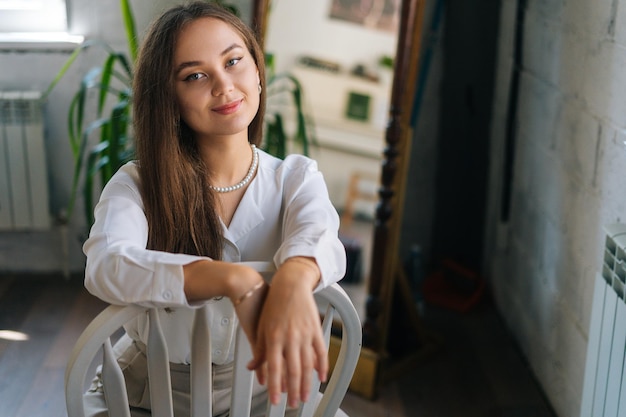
[274, 156, 346, 290]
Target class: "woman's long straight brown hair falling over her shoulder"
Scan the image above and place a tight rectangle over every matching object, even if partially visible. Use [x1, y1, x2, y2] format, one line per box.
[133, 2, 265, 259]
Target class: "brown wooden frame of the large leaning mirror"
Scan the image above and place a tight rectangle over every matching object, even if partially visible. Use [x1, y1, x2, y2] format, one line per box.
[252, 0, 433, 398]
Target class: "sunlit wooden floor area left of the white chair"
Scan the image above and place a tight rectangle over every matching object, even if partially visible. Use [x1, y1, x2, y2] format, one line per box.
[0, 276, 104, 417]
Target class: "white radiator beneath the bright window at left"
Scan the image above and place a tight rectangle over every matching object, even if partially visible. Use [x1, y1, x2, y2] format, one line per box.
[0, 91, 50, 230]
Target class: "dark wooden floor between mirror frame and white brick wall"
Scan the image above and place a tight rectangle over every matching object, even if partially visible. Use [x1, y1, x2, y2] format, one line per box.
[342, 300, 556, 417]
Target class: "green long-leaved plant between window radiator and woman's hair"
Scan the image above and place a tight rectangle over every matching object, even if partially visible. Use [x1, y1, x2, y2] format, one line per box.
[43, 0, 138, 225]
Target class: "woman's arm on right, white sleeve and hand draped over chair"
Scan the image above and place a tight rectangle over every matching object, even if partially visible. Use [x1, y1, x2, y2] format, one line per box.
[249, 155, 346, 406]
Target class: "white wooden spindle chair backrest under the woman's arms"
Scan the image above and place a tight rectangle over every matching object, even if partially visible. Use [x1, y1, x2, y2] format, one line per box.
[65, 263, 362, 417]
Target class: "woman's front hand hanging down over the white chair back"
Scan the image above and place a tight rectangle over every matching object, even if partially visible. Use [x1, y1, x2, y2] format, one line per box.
[248, 257, 328, 407]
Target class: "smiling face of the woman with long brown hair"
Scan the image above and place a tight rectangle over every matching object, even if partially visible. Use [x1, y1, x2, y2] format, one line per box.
[173, 17, 260, 139]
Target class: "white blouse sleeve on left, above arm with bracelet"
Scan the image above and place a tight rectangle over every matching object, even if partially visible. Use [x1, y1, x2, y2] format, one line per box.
[83, 164, 206, 307]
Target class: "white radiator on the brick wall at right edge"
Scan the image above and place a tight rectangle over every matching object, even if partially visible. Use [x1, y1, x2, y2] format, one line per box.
[580, 224, 626, 417]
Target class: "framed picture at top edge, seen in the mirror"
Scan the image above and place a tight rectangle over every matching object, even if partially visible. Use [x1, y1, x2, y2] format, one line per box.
[330, 0, 400, 32]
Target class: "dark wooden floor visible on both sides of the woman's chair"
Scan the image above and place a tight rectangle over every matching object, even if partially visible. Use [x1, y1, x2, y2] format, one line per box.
[0, 268, 554, 417]
